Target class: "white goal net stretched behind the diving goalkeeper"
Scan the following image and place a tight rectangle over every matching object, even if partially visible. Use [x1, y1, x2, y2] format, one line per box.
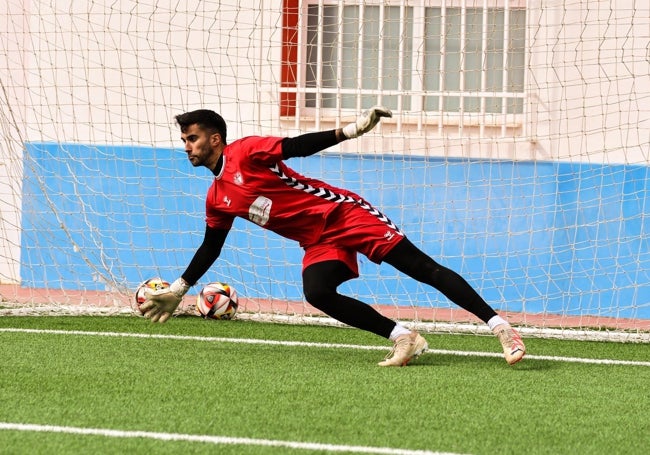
[0, 0, 650, 341]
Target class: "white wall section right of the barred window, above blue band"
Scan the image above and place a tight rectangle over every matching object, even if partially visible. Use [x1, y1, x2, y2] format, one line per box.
[528, 0, 650, 165]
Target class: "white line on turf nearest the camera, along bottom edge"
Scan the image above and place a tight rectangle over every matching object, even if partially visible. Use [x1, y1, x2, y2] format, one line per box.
[0, 422, 458, 455]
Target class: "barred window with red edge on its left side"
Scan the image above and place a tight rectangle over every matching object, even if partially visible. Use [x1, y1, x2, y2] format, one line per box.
[282, 0, 526, 126]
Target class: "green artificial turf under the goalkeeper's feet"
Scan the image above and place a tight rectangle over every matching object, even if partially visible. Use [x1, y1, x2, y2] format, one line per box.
[0, 317, 650, 455]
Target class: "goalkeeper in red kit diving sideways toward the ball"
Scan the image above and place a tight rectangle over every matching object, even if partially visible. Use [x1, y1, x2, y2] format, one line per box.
[141, 106, 526, 366]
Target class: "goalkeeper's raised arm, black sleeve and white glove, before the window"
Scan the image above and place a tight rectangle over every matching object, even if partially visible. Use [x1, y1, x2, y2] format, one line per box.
[282, 106, 393, 159]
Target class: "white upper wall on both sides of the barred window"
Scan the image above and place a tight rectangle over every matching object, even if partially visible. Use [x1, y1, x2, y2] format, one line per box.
[0, 0, 650, 155]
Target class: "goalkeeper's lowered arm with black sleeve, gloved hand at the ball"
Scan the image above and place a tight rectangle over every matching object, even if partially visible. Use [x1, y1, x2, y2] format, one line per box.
[140, 226, 228, 323]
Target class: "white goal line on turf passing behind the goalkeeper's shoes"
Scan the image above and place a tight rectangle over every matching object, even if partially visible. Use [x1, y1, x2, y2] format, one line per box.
[0, 327, 650, 367]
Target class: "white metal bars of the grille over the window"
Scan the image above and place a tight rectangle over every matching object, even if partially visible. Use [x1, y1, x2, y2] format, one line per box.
[292, 0, 529, 136]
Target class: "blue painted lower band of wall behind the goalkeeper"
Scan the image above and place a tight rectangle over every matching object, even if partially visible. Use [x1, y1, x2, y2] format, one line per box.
[21, 143, 650, 318]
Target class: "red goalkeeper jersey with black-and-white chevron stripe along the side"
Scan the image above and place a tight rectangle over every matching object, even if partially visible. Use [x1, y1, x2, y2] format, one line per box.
[206, 136, 361, 245]
